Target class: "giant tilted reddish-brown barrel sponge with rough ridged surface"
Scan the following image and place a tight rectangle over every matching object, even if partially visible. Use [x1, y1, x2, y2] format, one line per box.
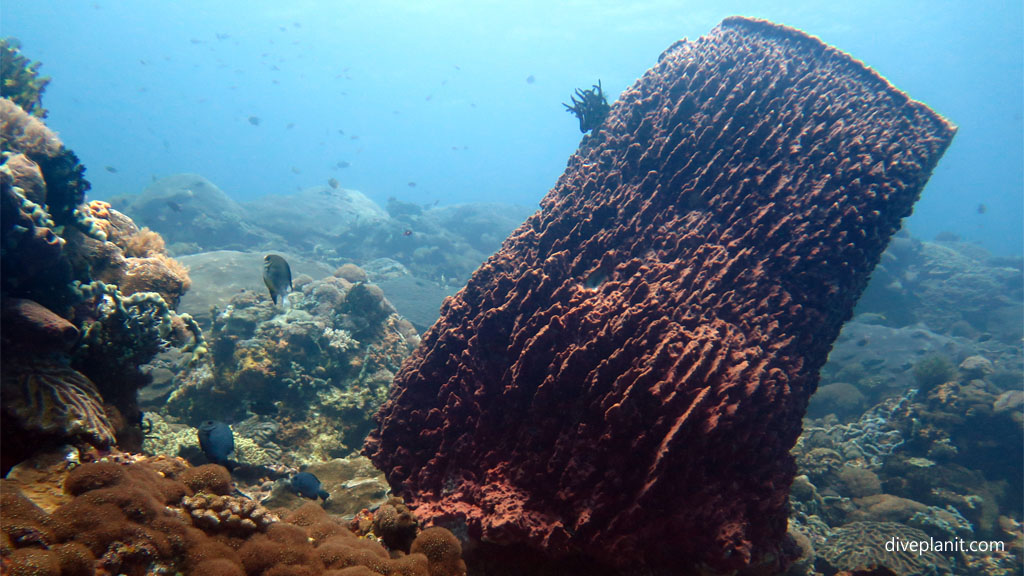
[365, 17, 955, 574]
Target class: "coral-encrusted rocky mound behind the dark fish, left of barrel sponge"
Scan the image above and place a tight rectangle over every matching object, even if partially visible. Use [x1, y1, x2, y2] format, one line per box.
[166, 276, 419, 465]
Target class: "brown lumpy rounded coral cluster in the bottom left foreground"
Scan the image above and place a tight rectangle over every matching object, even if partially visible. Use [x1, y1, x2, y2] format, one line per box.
[0, 456, 466, 576]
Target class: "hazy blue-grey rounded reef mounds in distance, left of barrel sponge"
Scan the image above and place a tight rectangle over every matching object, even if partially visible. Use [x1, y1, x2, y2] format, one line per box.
[117, 174, 534, 323]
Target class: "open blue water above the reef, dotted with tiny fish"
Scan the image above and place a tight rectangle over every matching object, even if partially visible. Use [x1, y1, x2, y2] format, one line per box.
[0, 0, 1024, 254]
